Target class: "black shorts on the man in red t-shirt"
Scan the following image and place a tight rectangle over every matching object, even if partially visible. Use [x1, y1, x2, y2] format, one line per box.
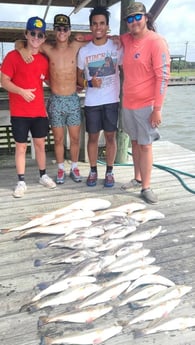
[11, 116, 49, 143]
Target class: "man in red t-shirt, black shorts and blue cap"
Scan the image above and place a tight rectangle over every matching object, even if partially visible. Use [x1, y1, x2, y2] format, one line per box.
[1, 17, 56, 198]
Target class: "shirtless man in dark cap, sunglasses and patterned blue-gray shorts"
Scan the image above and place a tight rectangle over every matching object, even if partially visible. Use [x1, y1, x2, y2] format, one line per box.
[16, 14, 84, 184]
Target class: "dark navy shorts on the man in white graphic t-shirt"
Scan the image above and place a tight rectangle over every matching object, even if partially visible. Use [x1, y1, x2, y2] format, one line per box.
[85, 102, 119, 133]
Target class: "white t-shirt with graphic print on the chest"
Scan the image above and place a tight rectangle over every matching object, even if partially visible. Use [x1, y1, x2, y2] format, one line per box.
[78, 39, 123, 106]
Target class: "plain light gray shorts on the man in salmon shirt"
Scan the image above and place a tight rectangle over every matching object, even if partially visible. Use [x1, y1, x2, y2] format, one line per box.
[122, 106, 160, 145]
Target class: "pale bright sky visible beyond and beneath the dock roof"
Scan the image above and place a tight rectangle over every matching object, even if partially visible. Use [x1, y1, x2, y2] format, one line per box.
[0, 0, 195, 61]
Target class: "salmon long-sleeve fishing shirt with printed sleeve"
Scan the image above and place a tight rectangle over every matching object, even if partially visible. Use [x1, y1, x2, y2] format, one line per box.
[120, 31, 170, 109]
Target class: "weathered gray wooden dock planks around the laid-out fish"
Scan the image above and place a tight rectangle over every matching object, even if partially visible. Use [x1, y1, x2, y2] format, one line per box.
[0, 141, 195, 345]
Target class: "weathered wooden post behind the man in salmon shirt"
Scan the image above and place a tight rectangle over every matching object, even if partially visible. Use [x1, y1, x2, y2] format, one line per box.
[115, 0, 134, 164]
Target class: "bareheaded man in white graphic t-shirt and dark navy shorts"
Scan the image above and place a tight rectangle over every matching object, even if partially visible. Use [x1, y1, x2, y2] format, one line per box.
[78, 6, 122, 187]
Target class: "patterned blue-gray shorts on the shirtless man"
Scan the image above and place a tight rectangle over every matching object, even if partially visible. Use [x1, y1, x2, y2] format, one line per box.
[47, 93, 81, 127]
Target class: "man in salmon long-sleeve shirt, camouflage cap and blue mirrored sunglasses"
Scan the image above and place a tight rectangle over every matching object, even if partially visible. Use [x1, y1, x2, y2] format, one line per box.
[121, 2, 170, 204]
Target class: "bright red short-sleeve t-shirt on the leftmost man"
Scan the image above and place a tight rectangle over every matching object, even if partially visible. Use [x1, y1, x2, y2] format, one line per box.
[1, 50, 48, 117]
